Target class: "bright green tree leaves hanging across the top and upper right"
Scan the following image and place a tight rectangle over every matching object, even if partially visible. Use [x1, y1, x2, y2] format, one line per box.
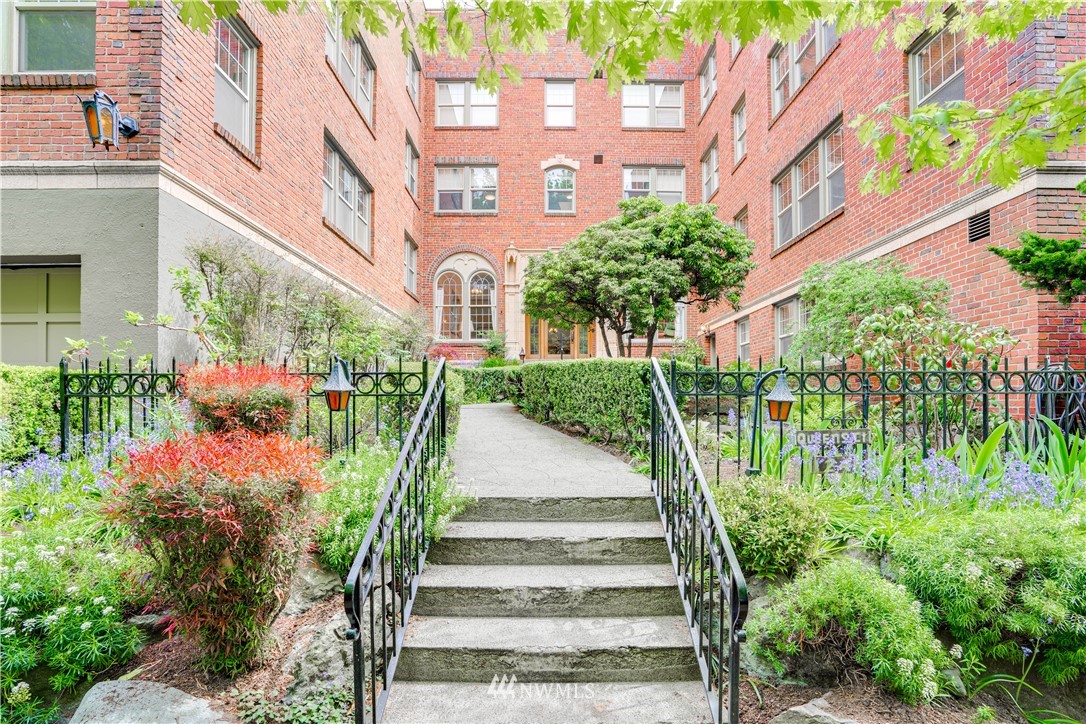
[160, 0, 1086, 194]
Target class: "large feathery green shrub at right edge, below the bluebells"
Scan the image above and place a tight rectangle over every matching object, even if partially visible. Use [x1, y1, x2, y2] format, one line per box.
[888, 504, 1086, 684]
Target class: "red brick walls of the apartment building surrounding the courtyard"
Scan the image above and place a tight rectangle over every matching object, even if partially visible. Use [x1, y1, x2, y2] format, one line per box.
[0, 0, 1086, 360]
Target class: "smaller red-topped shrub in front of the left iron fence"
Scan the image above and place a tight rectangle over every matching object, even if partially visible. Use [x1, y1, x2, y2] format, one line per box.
[180, 364, 310, 434]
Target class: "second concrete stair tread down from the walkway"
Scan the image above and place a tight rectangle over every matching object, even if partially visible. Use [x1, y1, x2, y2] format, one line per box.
[419, 563, 678, 598]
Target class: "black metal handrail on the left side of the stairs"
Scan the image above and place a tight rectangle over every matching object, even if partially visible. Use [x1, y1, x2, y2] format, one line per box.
[343, 358, 446, 724]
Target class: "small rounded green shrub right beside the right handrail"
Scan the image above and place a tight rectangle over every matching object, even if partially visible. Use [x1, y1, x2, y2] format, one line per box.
[712, 477, 826, 579]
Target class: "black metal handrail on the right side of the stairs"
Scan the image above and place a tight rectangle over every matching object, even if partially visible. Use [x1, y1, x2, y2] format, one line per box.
[649, 359, 747, 724]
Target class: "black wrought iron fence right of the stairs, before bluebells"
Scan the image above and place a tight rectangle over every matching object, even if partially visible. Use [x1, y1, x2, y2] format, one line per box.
[669, 360, 1086, 484]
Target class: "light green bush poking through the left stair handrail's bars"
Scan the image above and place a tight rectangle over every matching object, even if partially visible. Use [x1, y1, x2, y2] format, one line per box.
[315, 442, 468, 575]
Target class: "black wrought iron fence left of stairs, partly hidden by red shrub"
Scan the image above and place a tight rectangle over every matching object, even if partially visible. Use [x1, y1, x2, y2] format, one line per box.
[59, 359, 429, 453]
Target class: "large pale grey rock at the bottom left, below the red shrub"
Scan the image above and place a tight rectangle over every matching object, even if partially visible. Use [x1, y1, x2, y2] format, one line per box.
[70, 681, 229, 724]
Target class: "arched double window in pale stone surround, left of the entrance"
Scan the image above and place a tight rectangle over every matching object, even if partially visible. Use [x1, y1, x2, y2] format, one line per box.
[433, 254, 497, 342]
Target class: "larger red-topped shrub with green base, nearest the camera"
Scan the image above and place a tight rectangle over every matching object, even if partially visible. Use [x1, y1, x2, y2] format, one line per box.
[109, 431, 325, 674]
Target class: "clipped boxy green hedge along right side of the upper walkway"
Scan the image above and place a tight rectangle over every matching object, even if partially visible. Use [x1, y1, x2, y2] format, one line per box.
[508, 359, 652, 447]
